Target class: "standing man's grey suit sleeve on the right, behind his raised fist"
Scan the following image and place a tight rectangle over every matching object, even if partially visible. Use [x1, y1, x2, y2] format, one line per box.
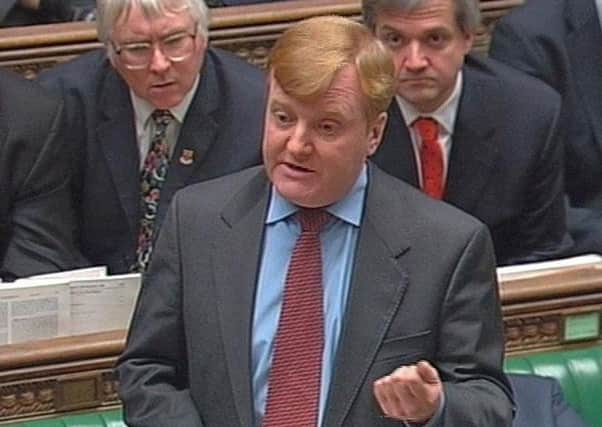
[436, 227, 513, 427]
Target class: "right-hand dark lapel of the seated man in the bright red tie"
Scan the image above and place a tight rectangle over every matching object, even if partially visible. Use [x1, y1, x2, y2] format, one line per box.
[444, 60, 502, 212]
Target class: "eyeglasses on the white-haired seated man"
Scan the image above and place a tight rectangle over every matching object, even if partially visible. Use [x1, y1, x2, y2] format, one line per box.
[111, 30, 197, 70]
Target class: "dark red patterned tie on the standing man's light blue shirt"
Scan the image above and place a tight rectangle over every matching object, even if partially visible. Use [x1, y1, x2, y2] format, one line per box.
[263, 209, 330, 427]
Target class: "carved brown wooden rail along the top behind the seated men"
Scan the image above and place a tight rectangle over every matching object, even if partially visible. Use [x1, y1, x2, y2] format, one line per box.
[0, 0, 524, 78]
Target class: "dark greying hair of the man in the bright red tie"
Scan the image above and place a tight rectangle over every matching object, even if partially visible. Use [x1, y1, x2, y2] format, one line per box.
[362, 0, 481, 33]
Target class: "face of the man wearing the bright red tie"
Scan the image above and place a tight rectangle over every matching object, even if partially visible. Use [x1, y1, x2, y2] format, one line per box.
[375, 0, 474, 113]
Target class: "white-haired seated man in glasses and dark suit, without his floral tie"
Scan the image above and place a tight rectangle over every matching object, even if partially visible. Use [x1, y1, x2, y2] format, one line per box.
[40, 0, 265, 273]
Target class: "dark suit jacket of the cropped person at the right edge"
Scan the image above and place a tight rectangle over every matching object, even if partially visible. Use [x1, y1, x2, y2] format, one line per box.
[490, 0, 602, 252]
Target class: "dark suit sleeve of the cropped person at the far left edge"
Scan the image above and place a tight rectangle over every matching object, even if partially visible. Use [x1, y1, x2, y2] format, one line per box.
[0, 99, 86, 277]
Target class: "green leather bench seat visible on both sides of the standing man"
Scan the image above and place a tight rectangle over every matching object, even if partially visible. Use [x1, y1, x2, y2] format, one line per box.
[9, 347, 602, 427]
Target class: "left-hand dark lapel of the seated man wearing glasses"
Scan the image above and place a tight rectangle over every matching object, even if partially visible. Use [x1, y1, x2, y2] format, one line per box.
[96, 70, 140, 237]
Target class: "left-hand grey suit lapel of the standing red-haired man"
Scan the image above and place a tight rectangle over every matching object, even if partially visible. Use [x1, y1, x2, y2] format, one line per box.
[213, 168, 269, 426]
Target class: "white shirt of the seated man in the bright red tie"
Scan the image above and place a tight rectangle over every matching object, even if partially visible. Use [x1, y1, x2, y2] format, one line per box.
[395, 71, 462, 186]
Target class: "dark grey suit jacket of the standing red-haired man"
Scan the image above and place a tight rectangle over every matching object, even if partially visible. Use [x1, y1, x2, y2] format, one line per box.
[117, 165, 512, 427]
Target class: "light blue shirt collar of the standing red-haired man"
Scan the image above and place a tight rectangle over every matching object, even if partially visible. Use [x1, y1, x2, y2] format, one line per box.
[265, 165, 368, 227]
